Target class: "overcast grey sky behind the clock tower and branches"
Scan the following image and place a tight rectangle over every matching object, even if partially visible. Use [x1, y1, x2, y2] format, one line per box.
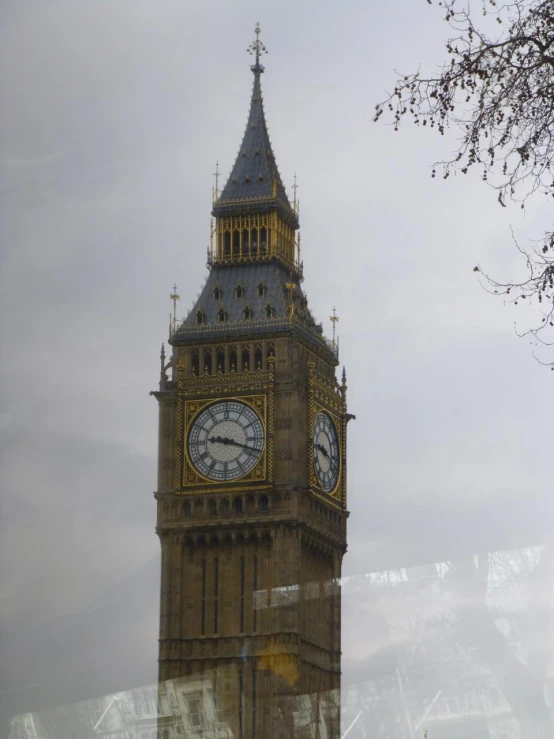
[0, 0, 554, 736]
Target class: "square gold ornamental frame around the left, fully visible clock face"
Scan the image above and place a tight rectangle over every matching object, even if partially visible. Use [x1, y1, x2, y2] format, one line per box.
[175, 393, 273, 493]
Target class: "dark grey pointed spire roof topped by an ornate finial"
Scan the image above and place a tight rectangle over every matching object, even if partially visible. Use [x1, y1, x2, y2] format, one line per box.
[213, 24, 298, 228]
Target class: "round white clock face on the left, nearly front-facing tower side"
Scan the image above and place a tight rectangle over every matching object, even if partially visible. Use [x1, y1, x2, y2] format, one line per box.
[188, 400, 264, 482]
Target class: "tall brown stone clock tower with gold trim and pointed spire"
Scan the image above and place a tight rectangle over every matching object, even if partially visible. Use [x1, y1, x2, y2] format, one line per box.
[154, 26, 351, 739]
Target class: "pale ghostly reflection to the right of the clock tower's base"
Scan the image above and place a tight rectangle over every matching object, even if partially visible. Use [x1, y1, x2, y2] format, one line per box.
[336, 547, 554, 739]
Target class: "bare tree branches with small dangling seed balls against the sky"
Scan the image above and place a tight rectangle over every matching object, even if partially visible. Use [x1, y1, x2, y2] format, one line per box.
[374, 0, 554, 369]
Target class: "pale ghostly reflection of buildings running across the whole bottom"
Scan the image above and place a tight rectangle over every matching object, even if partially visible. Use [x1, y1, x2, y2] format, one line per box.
[9, 547, 554, 739]
